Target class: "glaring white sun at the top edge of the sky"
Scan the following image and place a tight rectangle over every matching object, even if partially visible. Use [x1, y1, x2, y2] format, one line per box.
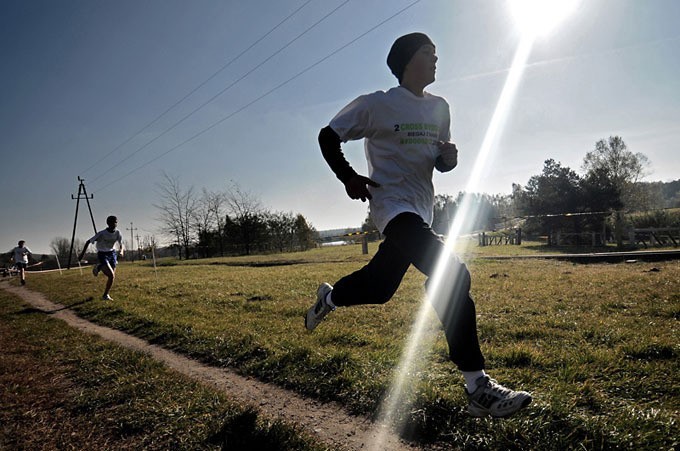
[508, 0, 580, 36]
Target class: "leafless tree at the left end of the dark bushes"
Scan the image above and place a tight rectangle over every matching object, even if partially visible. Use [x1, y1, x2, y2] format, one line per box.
[154, 172, 198, 258]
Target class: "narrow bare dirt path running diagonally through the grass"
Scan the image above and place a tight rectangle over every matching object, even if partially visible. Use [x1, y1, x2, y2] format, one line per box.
[0, 282, 417, 450]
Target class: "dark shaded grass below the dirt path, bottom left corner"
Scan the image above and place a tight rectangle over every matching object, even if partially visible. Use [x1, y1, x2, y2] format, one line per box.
[0, 291, 324, 451]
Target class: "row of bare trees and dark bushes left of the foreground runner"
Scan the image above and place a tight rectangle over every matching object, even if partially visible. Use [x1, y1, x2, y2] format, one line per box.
[154, 173, 317, 258]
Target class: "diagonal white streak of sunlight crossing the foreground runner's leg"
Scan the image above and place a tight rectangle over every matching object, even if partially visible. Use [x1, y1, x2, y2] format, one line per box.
[369, 35, 533, 450]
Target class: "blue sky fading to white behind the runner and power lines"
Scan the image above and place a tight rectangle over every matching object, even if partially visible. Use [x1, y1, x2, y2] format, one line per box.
[0, 0, 680, 253]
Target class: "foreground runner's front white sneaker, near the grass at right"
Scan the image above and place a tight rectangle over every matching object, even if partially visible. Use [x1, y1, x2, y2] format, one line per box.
[465, 376, 531, 418]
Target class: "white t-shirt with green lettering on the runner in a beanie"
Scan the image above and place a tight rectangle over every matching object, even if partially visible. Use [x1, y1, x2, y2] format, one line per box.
[330, 86, 451, 232]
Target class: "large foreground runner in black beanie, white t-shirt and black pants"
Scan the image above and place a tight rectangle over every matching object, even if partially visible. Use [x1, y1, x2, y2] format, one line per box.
[305, 33, 531, 417]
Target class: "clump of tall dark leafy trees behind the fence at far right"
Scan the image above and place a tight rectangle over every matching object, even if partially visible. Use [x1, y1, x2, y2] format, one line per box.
[513, 136, 674, 244]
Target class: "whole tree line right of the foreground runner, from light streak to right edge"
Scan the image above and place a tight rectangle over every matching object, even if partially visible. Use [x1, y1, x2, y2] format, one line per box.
[422, 136, 680, 242]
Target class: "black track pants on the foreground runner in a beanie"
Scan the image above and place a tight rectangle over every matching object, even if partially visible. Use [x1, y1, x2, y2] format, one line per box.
[332, 213, 484, 371]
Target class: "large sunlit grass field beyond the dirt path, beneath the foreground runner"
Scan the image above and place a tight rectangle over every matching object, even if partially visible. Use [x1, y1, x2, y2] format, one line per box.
[6, 242, 680, 450]
